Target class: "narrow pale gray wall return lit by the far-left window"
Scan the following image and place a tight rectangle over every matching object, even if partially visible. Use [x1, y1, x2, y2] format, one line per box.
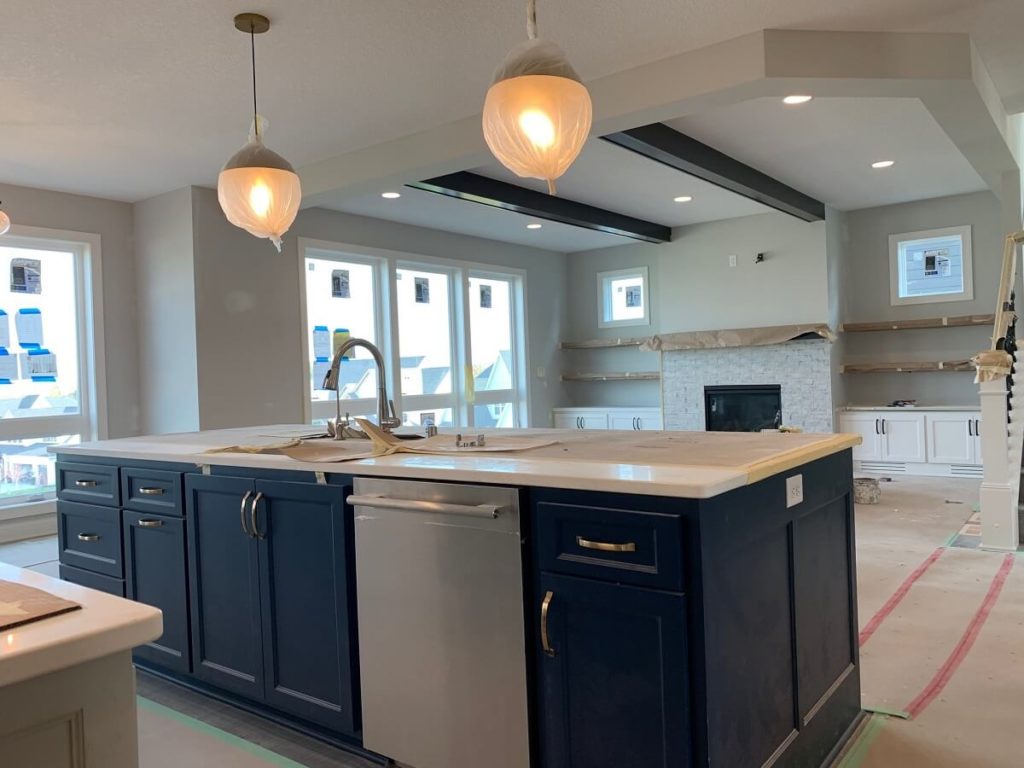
[134, 187, 200, 434]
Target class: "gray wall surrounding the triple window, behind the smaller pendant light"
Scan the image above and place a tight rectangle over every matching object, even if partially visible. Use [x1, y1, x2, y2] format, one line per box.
[184, 187, 566, 429]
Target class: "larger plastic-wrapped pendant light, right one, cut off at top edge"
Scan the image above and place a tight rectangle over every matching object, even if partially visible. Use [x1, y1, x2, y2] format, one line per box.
[483, 0, 593, 195]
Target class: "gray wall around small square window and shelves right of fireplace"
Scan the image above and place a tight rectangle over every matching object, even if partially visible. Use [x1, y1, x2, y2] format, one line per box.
[838, 191, 1007, 406]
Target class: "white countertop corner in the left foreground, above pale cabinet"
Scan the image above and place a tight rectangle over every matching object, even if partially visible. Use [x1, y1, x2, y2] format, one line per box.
[0, 563, 164, 686]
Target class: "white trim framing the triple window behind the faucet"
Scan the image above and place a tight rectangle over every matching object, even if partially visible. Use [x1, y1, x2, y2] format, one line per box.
[296, 238, 528, 427]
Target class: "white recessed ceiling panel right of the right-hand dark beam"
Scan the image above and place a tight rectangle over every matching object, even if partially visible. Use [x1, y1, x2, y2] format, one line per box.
[668, 98, 986, 211]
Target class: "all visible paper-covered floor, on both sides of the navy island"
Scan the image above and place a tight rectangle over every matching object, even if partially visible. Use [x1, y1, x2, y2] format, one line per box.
[0, 476, 1024, 768]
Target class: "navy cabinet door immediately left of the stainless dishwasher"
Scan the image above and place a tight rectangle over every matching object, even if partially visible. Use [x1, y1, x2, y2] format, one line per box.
[256, 480, 359, 733]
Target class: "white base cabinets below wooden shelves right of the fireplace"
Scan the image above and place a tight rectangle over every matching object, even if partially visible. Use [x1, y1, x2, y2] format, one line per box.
[839, 410, 982, 477]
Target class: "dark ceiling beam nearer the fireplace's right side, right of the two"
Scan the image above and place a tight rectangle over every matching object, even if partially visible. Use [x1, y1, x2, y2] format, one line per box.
[602, 123, 825, 221]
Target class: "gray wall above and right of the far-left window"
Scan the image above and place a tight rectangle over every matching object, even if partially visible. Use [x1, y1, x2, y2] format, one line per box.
[0, 177, 140, 437]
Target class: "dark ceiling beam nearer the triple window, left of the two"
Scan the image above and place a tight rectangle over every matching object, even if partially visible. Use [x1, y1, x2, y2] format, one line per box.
[407, 171, 672, 243]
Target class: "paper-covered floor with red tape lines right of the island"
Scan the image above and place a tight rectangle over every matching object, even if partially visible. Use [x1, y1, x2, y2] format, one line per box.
[838, 476, 1024, 768]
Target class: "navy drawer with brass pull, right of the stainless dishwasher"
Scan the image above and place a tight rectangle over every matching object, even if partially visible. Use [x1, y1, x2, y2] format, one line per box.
[536, 502, 683, 592]
